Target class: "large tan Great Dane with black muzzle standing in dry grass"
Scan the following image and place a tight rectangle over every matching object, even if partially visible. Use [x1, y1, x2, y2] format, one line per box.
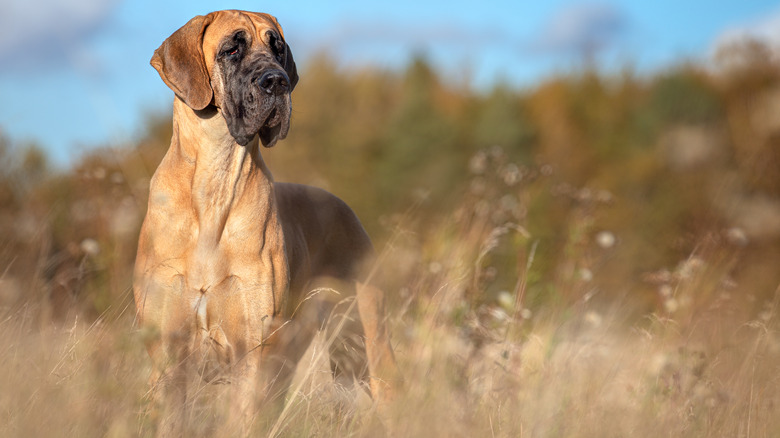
[134, 11, 398, 434]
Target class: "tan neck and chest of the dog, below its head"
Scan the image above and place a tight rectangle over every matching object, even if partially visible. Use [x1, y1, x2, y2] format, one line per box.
[136, 98, 289, 321]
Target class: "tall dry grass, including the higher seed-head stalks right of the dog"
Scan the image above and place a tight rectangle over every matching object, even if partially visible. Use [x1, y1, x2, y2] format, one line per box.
[0, 149, 780, 437]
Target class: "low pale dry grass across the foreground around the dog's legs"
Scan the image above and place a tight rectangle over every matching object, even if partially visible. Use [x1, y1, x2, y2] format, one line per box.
[0, 255, 780, 437]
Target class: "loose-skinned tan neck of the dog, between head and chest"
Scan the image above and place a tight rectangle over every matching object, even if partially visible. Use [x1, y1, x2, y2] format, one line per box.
[171, 98, 274, 247]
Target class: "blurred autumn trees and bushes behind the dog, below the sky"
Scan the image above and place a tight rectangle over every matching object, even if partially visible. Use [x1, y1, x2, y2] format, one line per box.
[0, 38, 780, 326]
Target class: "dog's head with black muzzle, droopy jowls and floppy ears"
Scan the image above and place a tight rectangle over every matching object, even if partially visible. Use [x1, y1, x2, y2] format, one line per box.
[151, 11, 298, 147]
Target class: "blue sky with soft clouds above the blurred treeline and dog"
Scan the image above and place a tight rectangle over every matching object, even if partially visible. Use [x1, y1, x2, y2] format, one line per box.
[0, 0, 780, 165]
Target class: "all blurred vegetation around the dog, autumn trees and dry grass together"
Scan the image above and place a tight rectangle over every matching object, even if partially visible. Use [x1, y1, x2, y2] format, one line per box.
[0, 41, 780, 437]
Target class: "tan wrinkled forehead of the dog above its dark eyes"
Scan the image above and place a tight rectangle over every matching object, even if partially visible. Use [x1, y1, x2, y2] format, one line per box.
[203, 11, 282, 71]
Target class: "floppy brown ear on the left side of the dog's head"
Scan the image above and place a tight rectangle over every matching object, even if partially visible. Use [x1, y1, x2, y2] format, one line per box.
[150, 14, 214, 110]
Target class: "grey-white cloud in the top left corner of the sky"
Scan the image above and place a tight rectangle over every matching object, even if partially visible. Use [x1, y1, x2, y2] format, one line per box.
[0, 0, 118, 68]
